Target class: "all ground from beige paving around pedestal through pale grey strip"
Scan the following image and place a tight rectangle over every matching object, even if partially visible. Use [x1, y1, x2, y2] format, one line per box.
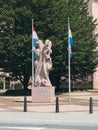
[0, 92, 98, 126]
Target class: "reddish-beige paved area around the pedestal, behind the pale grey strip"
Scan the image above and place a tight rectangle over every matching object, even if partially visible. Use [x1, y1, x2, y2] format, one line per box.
[0, 91, 98, 114]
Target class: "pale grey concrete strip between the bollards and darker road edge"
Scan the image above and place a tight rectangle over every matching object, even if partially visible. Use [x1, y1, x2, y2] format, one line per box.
[0, 112, 98, 126]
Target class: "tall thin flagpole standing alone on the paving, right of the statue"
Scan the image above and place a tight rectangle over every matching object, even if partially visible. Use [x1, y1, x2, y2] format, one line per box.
[68, 17, 71, 102]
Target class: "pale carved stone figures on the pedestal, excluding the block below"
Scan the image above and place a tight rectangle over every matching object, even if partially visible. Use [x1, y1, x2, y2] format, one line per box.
[34, 40, 52, 87]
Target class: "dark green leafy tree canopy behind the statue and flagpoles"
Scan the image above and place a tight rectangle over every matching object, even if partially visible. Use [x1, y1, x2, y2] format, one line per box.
[0, 0, 97, 88]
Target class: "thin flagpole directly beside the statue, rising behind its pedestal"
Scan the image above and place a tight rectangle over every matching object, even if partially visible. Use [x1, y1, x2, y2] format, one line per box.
[32, 19, 34, 87]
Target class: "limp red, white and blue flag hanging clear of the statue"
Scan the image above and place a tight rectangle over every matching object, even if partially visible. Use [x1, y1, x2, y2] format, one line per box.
[68, 25, 74, 59]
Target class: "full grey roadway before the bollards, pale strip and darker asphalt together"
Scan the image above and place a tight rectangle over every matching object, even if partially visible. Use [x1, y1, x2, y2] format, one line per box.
[0, 112, 98, 130]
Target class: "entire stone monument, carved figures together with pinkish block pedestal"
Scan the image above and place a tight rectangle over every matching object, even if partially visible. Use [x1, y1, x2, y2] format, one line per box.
[32, 40, 55, 103]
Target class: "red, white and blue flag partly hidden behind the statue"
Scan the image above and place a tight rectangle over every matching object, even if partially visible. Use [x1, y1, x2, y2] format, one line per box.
[32, 27, 38, 60]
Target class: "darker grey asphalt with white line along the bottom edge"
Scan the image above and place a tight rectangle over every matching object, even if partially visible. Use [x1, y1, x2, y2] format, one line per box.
[0, 123, 98, 130]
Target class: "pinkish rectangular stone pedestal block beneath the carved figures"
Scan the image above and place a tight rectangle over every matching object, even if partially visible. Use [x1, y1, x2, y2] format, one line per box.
[32, 87, 55, 103]
